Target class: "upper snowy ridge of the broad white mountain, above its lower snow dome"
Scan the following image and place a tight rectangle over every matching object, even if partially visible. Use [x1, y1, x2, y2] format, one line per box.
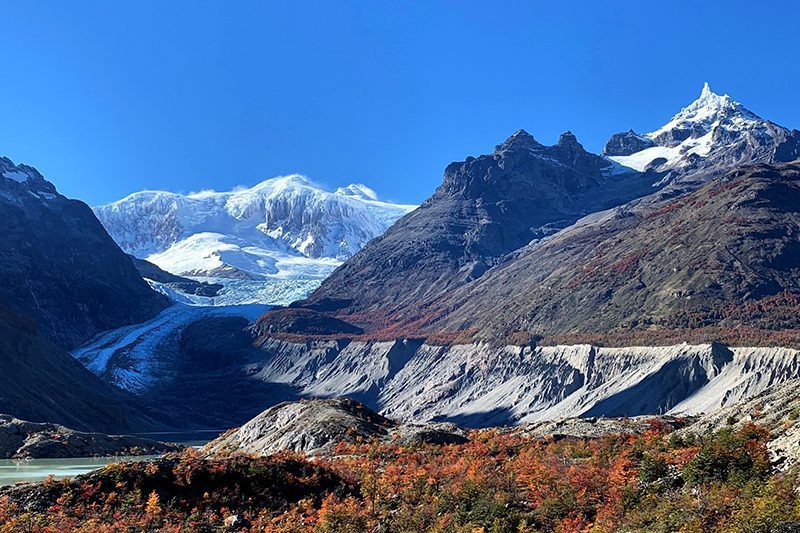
[95, 174, 415, 268]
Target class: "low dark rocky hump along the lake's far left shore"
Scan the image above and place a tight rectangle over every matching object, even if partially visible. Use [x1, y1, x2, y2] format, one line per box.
[0, 415, 182, 459]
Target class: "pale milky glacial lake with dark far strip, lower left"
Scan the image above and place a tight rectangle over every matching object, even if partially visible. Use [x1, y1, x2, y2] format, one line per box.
[0, 430, 222, 486]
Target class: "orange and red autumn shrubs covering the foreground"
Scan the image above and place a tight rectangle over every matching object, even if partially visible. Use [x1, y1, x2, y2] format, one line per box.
[0, 420, 800, 533]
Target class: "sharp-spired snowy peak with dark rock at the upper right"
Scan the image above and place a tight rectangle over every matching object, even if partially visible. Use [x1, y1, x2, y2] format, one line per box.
[603, 83, 800, 181]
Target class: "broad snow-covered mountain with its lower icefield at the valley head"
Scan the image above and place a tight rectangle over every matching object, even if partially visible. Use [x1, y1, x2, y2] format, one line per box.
[95, 175, 415, 304]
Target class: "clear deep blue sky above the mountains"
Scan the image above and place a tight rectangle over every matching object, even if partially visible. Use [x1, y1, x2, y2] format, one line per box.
[0, 0, 800, 204]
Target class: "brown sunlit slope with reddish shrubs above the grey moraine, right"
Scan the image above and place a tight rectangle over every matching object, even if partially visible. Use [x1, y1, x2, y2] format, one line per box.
[432, 163, 800, 344]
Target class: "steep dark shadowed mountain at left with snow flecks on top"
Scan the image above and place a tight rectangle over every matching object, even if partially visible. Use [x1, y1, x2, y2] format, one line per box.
[0, 158, 169, 355]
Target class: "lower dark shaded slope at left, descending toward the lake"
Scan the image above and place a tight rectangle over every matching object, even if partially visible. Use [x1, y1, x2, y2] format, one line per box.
[0, 300, 164, 432]
